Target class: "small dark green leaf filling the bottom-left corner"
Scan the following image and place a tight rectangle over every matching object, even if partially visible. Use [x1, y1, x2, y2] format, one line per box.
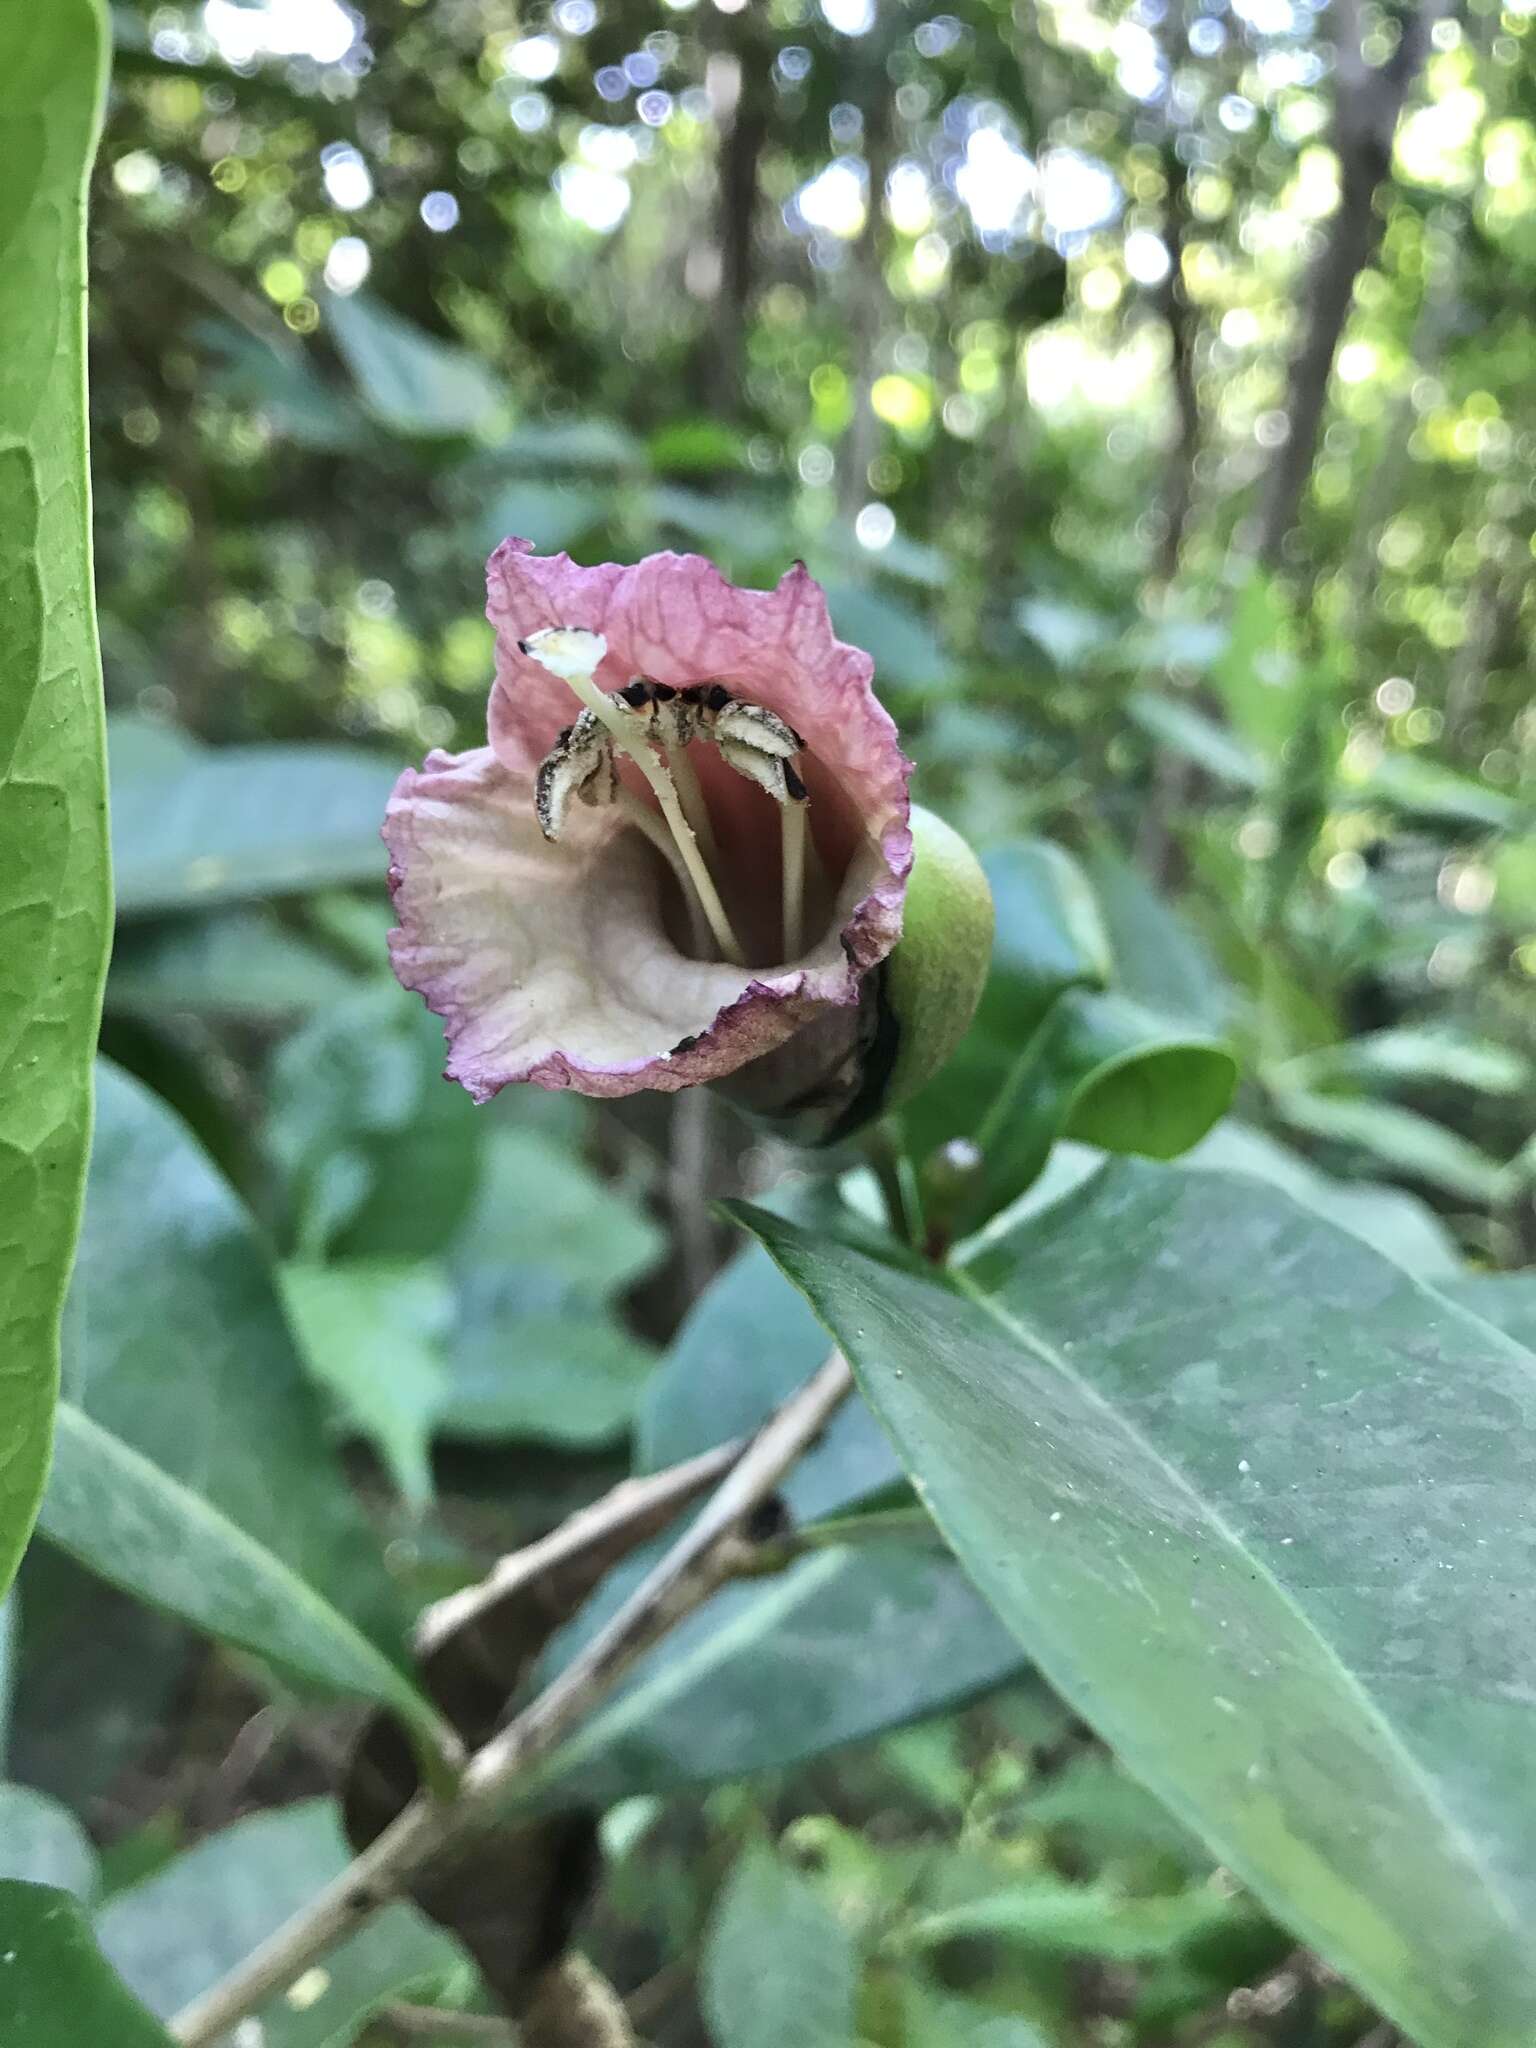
[0, 1880, 174, 2048]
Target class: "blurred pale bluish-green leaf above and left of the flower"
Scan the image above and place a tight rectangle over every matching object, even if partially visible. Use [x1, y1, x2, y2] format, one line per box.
[326, 291, 508, 436]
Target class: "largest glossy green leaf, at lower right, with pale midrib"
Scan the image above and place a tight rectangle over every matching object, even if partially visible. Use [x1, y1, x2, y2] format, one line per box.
[752, 1163, 1536, 2048]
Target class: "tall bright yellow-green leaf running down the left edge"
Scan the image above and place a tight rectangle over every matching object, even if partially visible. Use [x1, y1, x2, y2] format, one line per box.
[0, 0, 111, 1593]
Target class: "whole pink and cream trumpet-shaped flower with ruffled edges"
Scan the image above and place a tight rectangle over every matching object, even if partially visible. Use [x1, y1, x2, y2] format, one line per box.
[383, 541, 911, 1102]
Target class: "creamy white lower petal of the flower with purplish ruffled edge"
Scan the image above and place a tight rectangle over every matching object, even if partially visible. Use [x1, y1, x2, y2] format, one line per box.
[383, 749, 901, 1102]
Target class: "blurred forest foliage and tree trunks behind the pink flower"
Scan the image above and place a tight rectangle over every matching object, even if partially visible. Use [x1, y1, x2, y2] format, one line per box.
[6, 0, 1536, 2048]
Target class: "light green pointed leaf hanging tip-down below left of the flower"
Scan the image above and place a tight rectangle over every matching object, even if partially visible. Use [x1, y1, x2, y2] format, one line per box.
[279, 1260, 453, 1509]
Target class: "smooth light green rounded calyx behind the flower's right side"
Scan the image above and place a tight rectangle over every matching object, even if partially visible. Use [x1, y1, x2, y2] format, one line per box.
[881, 805, 993, 1110]
